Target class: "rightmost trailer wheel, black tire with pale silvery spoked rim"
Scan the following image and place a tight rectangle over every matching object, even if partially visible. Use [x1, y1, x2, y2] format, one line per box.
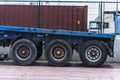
[79, 40, 107, 67]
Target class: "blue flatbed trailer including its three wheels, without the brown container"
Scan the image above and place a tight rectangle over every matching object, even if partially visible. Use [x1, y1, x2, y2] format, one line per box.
[0, 26, 115, 66]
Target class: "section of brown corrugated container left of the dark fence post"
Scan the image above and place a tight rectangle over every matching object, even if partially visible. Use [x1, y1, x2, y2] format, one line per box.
[0, 5, 36, 27]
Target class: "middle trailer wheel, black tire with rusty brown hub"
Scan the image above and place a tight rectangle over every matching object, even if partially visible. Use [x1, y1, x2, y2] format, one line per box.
[45, 39, 73, 66]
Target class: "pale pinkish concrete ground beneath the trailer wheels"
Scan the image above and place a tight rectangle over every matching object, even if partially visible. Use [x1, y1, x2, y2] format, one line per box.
[0, 61, 120, 80]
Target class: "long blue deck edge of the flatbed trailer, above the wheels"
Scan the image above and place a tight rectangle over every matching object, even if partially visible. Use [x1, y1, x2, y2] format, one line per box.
[0, 26, 115, 40]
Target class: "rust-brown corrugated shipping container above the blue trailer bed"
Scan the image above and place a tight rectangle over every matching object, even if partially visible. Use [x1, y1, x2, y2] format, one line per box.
[0, 5, 87, 31]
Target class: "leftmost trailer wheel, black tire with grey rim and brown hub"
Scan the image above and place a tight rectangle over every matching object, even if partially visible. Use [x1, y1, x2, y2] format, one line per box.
[11, 39, 37, 66]
